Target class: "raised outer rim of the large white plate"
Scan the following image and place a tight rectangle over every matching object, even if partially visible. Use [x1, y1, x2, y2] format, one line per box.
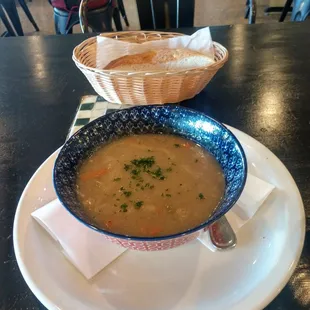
[13, 124, 306, 309]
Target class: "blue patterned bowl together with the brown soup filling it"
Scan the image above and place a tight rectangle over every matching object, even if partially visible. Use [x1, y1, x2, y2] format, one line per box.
[54, 105, 247, 251]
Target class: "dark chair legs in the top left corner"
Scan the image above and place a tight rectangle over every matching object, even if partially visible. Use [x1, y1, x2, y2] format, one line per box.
[0, 0, 40, 36]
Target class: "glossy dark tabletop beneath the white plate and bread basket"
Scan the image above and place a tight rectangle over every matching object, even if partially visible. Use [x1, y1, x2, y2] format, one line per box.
[0, 22, 310, 310]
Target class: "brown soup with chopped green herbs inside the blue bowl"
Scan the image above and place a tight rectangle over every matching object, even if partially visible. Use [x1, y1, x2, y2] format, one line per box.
[77, 134, 225, 237]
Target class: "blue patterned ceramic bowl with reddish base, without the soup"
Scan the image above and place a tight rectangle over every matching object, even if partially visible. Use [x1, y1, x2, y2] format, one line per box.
[54, 105, 247, 251]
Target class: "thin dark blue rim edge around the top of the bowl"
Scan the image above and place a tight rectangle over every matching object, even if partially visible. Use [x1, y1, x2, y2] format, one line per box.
[53, 104, 248, 242]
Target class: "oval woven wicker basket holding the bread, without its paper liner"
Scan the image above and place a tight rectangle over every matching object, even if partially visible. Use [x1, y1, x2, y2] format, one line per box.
[72, 31, 228, 105]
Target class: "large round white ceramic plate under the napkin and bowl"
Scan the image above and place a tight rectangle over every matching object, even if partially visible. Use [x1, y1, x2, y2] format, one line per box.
[14, 129, 305, 310]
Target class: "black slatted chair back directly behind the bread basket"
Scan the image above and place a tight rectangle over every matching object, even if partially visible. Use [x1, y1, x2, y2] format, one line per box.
[137, 0, 195, 30]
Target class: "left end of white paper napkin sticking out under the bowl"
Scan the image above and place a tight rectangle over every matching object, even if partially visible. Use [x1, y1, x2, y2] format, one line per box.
[31, 199, 126, 279]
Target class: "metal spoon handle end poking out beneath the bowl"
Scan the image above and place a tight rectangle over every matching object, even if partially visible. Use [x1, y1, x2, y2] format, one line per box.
[209, 215, 237, 250]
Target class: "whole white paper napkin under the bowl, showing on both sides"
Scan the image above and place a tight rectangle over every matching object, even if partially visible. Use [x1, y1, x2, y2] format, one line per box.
[32, 174, 274, 279]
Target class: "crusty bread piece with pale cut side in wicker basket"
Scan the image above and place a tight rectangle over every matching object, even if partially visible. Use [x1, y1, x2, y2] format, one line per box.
[105, 48, 214, 71]
